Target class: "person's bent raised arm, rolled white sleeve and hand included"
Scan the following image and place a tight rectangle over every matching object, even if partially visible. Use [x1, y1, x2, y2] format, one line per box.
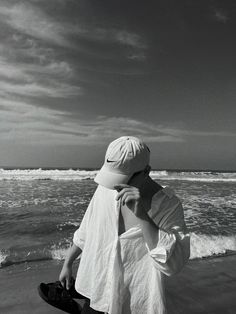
[116, 184, 190, 276]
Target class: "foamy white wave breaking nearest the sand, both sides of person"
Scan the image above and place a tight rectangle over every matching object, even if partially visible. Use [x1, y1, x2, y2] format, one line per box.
[0, 232, 236, 267]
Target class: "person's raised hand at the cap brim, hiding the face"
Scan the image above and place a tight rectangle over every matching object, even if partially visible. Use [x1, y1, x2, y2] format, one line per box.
[115, 184, 146, 218]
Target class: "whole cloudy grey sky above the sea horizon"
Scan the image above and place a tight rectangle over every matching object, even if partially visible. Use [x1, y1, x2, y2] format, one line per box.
[0, 0, 236, 170]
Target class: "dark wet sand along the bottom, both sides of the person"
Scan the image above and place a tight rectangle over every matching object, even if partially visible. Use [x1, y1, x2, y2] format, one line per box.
[0, 254, 236, 314]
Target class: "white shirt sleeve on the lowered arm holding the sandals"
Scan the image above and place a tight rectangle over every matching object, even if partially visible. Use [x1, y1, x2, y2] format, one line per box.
[73, 192, 96, 250]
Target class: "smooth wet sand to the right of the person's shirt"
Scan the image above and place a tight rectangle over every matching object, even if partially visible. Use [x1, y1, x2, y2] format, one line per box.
[166, 254, 236, 314]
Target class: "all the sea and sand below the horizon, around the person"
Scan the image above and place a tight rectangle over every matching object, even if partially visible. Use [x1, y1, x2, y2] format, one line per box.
[0, 169, 236, 314]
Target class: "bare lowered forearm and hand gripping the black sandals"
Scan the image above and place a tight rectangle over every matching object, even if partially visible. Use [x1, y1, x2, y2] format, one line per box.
[59, 243, 82, 289]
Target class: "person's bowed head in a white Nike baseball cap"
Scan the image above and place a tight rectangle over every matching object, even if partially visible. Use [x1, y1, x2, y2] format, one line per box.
[94, 136, 151, 189]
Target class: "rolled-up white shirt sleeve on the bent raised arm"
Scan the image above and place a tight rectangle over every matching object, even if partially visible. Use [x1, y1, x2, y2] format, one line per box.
[146, 189, 190, 276]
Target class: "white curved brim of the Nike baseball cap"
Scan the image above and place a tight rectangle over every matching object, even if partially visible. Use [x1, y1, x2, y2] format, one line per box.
[94, 166, 132, 190]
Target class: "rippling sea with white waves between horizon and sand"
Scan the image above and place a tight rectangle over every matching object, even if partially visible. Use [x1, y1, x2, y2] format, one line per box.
[0, 168, 236, 267]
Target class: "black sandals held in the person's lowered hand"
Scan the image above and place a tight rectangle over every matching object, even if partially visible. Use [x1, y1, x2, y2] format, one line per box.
[38, 281, 82, 314]
